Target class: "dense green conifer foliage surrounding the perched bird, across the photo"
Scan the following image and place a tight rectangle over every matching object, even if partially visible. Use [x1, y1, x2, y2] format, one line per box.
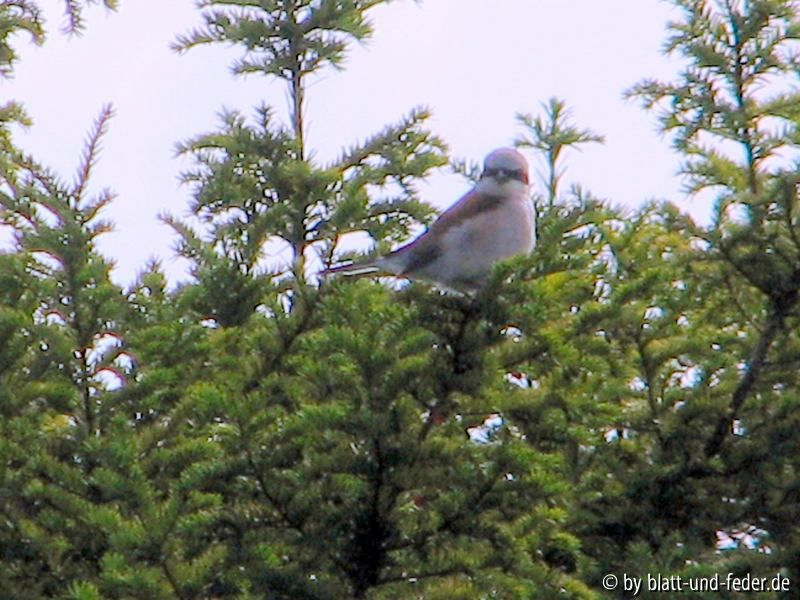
[0, 0, 800, 600]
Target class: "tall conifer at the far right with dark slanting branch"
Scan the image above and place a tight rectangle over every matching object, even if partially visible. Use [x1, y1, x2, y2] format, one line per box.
[564, 0, 800, 584]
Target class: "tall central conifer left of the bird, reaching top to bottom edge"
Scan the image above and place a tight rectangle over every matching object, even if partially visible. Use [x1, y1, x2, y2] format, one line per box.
[148, 1, 608, 598]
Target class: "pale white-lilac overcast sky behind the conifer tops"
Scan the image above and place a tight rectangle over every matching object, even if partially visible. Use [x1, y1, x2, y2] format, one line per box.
[0, 0, 692, 284]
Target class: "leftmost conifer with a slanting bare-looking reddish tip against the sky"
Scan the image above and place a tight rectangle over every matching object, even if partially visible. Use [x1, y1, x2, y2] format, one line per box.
[0, 107, 132, 597]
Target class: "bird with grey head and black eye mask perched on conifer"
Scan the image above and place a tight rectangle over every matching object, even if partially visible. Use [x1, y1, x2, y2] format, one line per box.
[320, 148, 535, 293]
